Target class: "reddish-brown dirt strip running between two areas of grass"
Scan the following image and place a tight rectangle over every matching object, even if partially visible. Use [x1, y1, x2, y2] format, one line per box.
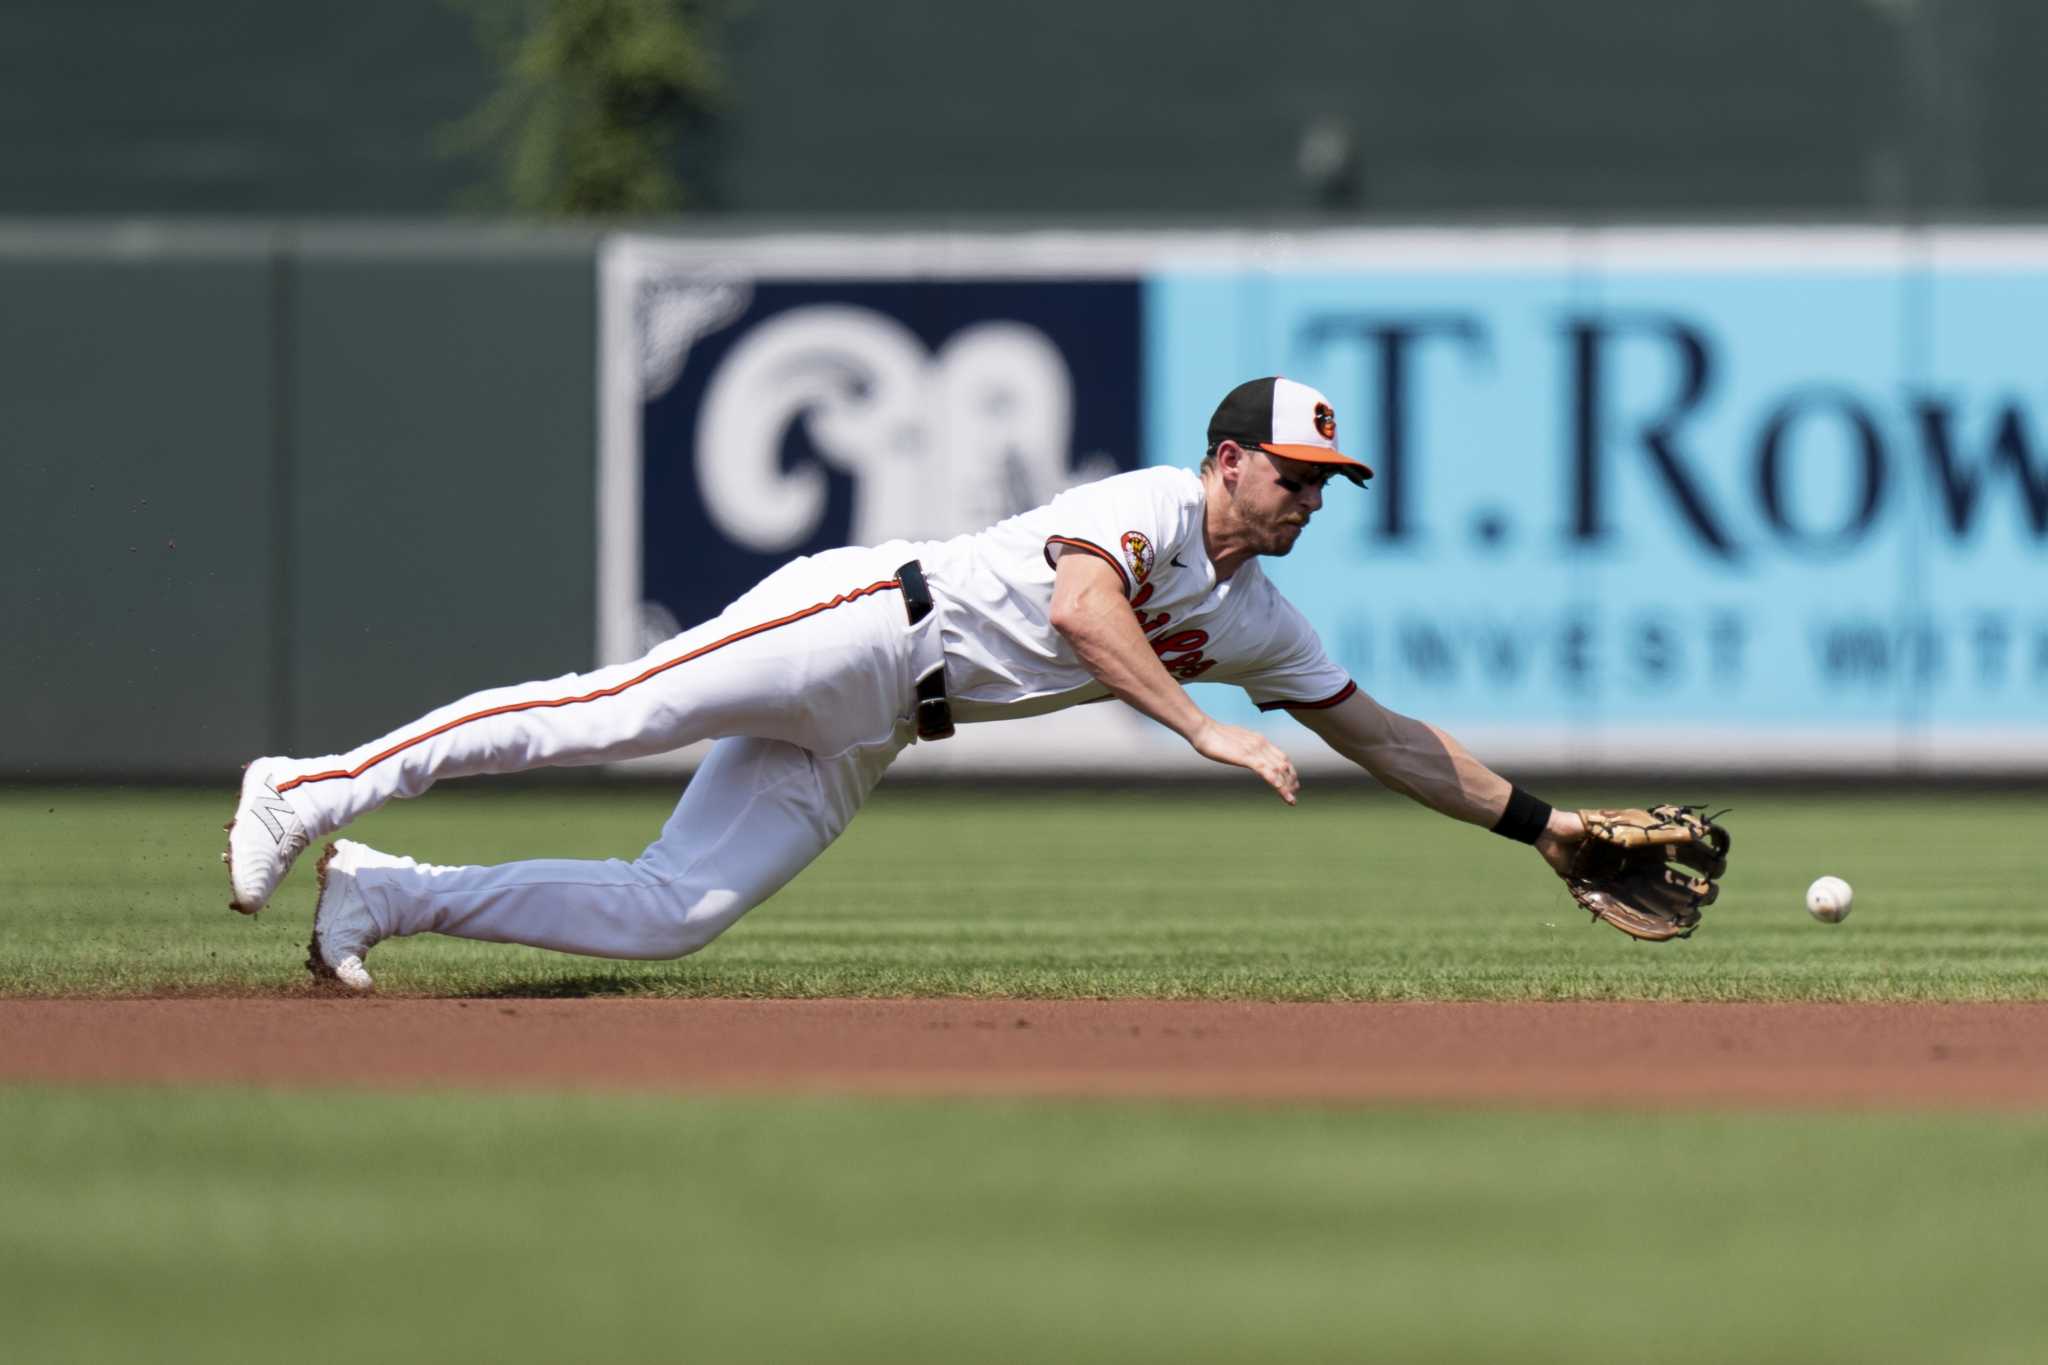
[0, 997, 2048, 1109]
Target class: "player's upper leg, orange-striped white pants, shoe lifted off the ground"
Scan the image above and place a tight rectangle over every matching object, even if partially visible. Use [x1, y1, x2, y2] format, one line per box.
[227, 551, 938, 913]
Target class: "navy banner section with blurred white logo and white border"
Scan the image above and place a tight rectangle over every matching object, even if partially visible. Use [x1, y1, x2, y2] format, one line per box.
[598, 239, 1145, 767]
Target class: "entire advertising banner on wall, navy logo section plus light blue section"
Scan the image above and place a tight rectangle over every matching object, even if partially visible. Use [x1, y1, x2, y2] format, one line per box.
[606, 229, 2048, 772]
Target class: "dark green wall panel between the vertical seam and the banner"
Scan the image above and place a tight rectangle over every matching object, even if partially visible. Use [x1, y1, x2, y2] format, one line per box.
[285, 239, 596, 753]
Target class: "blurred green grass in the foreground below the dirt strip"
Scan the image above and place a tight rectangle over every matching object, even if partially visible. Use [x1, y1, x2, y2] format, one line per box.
[0, 1089, 2048, 1365]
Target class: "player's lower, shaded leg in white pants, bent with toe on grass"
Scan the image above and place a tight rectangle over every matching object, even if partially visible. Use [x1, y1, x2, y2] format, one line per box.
[309, 724, 909, 988]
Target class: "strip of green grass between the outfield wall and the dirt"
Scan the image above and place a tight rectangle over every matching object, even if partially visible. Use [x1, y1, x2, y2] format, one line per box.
[0, 782, 2048, 1001]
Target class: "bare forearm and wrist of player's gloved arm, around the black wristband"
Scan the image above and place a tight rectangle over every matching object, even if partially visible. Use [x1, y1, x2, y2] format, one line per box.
[1294, 692, 1585, 855]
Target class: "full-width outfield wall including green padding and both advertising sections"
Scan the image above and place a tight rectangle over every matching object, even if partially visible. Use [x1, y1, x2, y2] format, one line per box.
[0, 225, 2048, 778]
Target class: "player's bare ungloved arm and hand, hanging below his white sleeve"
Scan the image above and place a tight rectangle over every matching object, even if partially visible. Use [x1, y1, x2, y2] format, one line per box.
[1053, 555, 1300, 806]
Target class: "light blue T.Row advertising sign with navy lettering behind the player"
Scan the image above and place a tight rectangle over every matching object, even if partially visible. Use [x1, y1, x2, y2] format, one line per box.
[1147, 231, 2048, 769]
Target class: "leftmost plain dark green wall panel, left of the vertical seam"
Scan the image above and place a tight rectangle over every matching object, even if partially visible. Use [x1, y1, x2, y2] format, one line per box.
[0, 235, 274, 778]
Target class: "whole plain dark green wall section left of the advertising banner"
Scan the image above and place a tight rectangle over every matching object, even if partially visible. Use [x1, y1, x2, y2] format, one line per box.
[0, 225, 596, 778]
